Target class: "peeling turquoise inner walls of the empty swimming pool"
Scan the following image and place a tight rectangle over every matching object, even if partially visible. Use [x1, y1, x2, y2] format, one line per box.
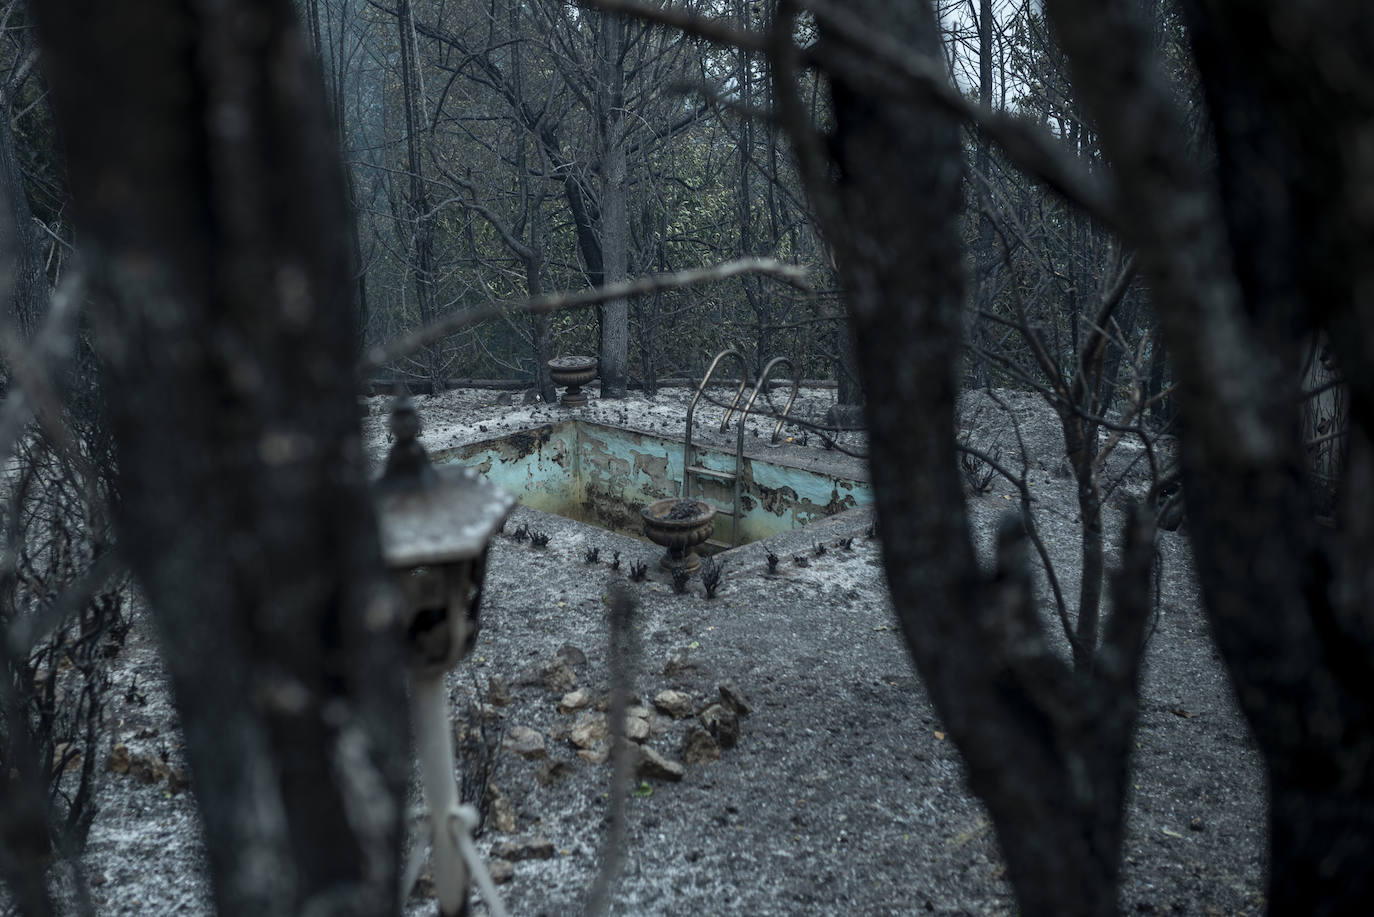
[433, 421, 872, 546]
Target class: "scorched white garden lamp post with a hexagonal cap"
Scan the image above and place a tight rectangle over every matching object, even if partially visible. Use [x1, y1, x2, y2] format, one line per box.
[375, 399, 515, 917]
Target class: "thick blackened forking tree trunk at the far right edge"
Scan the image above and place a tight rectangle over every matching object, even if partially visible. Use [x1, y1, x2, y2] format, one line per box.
[1046, 0, 1374, 914]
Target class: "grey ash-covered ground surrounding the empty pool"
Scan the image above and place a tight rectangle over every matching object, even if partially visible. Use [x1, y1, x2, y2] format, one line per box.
[26, 389, 1264, 916]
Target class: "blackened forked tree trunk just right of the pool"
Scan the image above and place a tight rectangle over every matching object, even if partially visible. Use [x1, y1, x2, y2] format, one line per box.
[774, 0, 1151, 917]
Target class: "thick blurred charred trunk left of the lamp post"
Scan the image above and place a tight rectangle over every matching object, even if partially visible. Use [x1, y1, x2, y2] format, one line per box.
[33, 0, 408, 916]
